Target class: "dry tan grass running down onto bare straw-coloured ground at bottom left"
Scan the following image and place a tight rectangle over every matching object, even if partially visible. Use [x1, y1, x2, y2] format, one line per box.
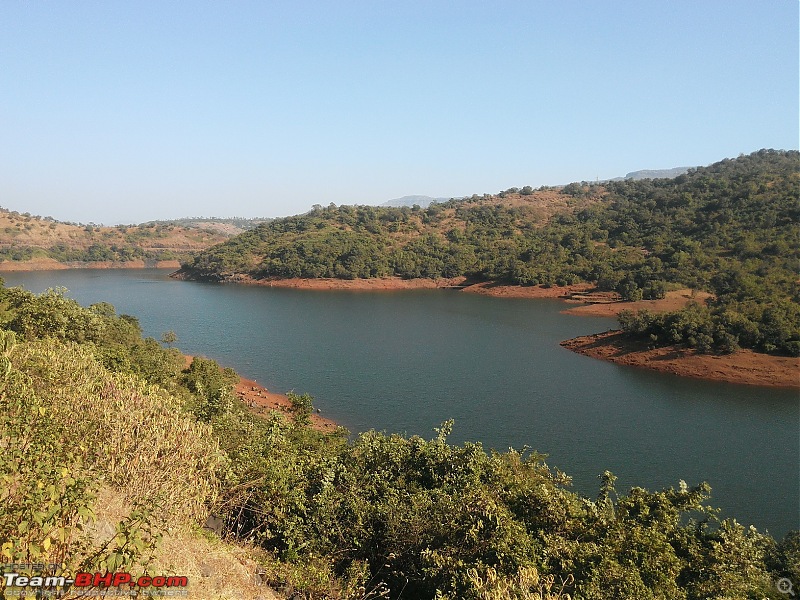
[0, 340, 277, 600]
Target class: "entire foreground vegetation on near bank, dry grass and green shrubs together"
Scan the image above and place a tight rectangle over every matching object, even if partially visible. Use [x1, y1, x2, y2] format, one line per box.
[0, 289, 800, 600]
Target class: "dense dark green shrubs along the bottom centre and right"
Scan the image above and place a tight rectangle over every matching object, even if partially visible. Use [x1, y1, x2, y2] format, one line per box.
[212, 396, 800, 600]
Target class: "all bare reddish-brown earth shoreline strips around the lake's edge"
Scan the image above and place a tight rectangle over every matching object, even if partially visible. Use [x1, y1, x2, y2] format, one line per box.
[12, 259, 800, 392]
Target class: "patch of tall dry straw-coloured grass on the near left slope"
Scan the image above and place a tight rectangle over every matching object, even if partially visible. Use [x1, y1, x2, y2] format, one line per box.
[13, 340, 222, 527]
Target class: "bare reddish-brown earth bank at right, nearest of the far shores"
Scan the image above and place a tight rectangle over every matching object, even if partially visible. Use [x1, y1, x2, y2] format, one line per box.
[561, 330, 800, 390]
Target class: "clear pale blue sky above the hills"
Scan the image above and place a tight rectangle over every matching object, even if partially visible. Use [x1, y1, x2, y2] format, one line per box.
[0, 0, 800, 224]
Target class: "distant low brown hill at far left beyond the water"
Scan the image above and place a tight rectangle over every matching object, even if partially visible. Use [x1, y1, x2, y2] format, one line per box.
[0, 208, 233, 270]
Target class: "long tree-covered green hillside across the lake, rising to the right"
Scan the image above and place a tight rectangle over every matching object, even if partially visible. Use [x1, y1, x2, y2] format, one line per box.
[180, 150, 800, 356]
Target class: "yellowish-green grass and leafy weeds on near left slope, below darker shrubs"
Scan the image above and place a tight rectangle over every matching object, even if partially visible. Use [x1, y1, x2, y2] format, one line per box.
[0, 331, 223, 584]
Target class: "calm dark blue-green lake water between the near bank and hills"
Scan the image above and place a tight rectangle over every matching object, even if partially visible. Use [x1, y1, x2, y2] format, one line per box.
[3, 269, 800, 537]
